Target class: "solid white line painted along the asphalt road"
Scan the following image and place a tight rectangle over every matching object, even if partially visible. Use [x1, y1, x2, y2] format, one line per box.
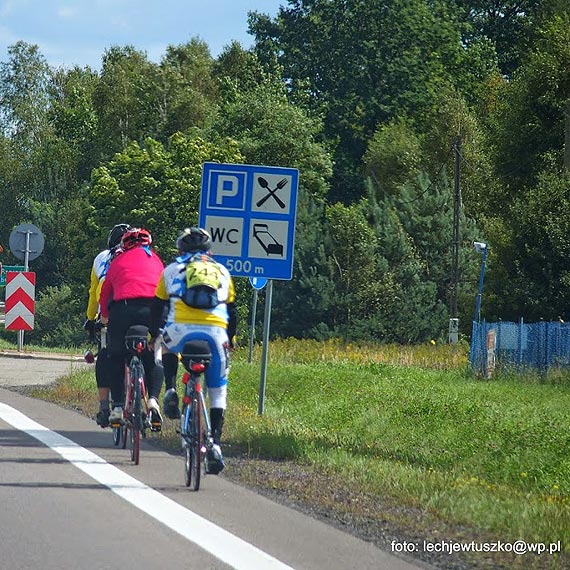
[0, 402, 293, 570]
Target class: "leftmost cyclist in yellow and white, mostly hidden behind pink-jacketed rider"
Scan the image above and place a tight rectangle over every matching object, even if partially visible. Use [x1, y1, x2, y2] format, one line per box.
[83, 224, 131, 427]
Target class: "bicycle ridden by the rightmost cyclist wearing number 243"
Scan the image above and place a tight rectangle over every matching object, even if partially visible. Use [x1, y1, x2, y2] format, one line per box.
[180, 340, 212, 491]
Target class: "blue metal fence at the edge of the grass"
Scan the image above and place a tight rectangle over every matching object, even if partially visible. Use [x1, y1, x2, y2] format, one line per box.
[469, 319, 570, 376]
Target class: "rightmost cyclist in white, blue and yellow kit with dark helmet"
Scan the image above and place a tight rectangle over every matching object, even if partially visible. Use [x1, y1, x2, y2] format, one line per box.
[150, 228, 237, 473]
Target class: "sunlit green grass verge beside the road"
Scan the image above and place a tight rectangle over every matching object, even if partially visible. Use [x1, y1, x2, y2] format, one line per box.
[21, 341, 570, 551]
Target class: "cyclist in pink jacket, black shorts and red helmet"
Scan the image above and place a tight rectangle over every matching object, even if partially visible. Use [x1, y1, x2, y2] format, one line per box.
[100, 228, 164, 431]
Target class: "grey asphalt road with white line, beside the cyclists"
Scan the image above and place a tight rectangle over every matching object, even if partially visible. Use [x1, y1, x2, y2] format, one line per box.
[0, 357, 426, 570]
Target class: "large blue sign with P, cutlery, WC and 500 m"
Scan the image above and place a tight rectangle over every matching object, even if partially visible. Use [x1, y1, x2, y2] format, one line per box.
[199, 162, 299, 279]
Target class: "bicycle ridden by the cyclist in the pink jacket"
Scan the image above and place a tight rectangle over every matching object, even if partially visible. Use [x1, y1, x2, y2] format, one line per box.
[111, 325, 151, 465]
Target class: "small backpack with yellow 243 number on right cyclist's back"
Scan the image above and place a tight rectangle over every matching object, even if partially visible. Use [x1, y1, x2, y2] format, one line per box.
[181, 255, 223, 309]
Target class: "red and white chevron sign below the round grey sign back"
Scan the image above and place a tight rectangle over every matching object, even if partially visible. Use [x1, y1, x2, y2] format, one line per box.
[5, 271, 36, 331]
